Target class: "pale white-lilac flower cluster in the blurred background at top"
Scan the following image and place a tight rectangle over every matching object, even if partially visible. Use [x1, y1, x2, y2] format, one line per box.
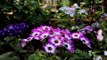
[59, 3, 88, 17]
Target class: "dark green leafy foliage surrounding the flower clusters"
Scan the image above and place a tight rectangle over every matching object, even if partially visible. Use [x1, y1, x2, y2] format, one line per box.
[0, 0, 107, 60]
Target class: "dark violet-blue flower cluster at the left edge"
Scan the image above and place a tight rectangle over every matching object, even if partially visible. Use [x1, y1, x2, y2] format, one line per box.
[0, 23, 29, 37]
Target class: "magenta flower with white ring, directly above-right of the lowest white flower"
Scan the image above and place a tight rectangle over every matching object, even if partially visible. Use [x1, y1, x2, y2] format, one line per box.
[49, 36, 64, 47]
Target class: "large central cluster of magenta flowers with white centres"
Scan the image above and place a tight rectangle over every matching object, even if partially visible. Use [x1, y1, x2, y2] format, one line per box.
[21, 26, 91, 53]
